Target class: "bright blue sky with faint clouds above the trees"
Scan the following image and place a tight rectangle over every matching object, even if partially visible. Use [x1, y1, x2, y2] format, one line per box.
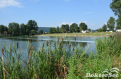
[0, 0, 118, 30]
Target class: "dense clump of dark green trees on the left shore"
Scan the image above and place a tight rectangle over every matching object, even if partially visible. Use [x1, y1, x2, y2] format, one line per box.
[0, 20, 38, 36]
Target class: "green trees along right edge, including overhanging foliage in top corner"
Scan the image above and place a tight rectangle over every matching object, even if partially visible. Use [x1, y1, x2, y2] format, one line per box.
[97, 0, 121, 31]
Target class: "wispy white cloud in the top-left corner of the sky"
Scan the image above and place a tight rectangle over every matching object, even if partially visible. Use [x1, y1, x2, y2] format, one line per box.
[0, 0, 23, 8]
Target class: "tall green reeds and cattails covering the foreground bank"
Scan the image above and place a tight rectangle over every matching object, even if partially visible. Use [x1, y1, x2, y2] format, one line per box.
[0, 34, 121, 79]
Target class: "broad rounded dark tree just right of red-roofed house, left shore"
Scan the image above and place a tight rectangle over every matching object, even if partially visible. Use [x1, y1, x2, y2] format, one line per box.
[8, 22, 20, 36]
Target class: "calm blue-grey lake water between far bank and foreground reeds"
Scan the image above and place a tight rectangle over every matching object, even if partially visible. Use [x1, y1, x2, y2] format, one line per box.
[0, 36, 101, 57]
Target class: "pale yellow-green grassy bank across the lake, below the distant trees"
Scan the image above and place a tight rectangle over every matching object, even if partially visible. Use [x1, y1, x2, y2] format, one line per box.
[35, 32, 115, 37]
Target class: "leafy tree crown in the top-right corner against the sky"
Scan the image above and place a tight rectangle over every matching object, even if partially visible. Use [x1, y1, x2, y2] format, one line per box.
[110, 0, 121, 15]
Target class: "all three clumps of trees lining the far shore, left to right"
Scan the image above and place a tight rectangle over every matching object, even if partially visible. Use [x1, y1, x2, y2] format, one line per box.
[0, 15, 121, 36]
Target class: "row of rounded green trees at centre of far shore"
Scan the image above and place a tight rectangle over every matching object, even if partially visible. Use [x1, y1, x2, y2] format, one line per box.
[49, 22, 88, 33]
